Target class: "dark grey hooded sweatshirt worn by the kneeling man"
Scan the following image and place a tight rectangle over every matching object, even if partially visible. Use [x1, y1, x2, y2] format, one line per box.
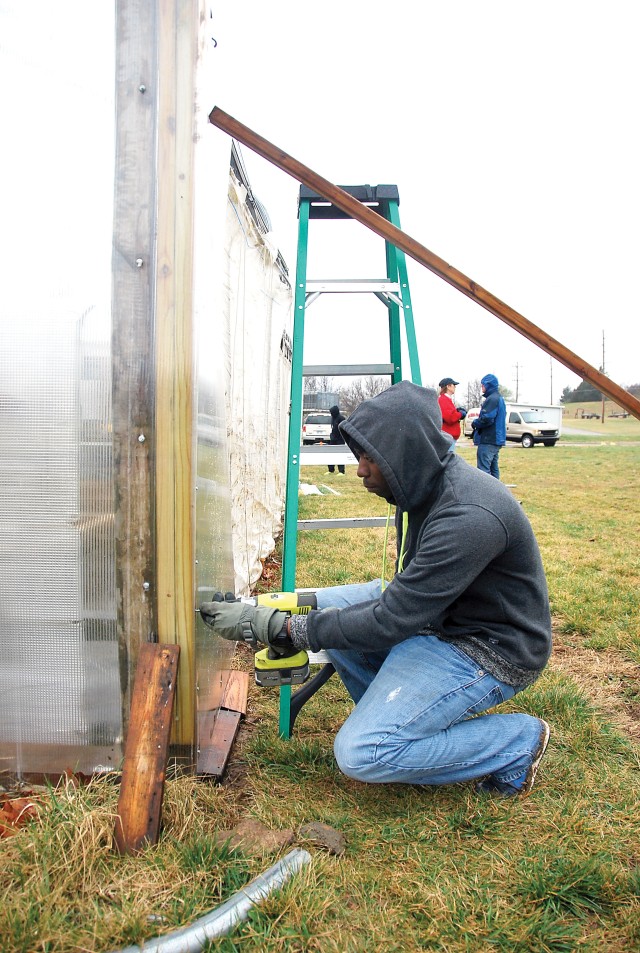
[291, 381, 551, 688]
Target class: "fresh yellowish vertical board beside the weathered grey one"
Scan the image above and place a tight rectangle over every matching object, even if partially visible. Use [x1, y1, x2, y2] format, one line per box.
[156, 0, 200, 745]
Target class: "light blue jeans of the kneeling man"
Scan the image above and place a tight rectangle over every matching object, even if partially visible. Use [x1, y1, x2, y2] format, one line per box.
[317, 579, 541, 784]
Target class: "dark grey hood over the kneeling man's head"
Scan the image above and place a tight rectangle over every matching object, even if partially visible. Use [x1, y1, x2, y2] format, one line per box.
[340, 381, 454, 512]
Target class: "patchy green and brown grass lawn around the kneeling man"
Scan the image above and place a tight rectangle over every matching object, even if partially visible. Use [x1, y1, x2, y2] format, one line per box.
[0, 442, 640, 953]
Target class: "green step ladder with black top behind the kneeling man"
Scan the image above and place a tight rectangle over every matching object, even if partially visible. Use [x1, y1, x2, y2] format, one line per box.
[279, 185, 422, 738]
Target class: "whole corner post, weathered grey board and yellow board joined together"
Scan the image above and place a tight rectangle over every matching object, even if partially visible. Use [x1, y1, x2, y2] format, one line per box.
[113, 0, 202, 746]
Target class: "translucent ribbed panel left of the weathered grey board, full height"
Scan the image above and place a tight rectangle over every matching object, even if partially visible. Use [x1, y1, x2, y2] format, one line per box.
[0, 0, 122, 775]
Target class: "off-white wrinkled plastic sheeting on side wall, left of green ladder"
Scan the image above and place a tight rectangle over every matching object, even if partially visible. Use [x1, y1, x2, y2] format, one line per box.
[220, 176, 292, 594]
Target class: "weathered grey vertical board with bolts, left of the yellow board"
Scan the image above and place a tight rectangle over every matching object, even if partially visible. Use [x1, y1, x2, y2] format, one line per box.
[112, 0, 158, 738]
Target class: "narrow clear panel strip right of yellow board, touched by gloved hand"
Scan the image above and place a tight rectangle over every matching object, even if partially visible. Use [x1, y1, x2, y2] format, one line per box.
[193, 108, 240, 712]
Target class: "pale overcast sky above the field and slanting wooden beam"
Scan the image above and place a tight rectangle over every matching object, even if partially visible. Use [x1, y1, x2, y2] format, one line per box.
[211, 0, 640, 403]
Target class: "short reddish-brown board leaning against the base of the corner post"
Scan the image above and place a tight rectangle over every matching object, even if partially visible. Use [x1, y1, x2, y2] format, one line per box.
[114, 642, 180, 854]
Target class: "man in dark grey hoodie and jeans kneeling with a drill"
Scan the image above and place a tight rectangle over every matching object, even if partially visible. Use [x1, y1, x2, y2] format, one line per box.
[201, 381, 551, 796]
